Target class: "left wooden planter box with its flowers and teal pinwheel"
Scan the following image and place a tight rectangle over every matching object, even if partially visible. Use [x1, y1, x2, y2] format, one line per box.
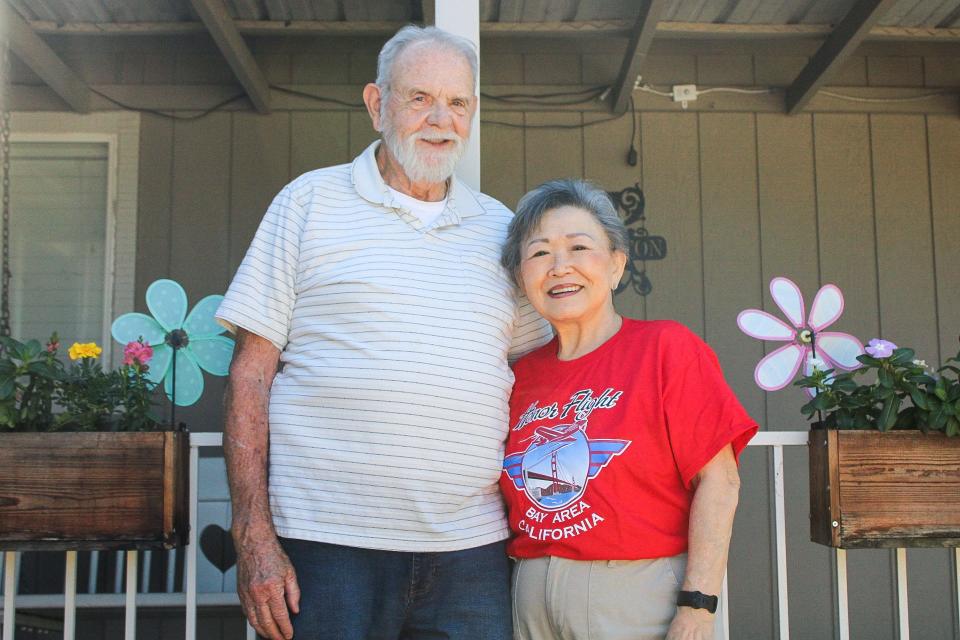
[0, 280, 233, 550]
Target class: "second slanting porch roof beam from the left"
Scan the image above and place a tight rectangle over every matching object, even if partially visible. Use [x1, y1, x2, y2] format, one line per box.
[190, 0, 270, 113]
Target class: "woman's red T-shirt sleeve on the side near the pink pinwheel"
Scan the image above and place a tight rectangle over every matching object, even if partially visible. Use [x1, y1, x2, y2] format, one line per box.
[663, 333, 759, 489]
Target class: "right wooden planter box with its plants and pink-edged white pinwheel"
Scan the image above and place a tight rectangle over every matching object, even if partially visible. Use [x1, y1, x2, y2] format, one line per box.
[737, 278, 960, 548]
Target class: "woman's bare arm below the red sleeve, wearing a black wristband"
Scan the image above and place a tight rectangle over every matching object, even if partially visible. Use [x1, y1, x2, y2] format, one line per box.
[666, 445, 740, 640]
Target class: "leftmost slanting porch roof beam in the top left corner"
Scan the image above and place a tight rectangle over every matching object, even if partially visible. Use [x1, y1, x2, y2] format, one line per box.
[0, 1, 92, 113]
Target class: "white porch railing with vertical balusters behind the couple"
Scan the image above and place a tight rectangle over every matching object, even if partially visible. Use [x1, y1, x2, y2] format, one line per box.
[0, 431, 960, 640]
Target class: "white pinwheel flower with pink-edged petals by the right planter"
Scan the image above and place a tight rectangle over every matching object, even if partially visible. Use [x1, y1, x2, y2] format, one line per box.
[737, 278, 863, 391]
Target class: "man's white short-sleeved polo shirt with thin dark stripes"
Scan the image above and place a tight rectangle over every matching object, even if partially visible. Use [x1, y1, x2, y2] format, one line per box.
[217, 143, 550, 551]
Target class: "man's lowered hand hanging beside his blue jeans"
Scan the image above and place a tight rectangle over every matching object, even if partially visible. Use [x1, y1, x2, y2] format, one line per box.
[237, 537, 300, 640]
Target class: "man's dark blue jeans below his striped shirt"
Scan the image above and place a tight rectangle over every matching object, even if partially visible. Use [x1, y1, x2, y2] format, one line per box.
[280, 538, 513, 640]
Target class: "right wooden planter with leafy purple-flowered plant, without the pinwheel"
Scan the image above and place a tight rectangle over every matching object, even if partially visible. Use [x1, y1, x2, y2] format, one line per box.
[796, 340, 960, 549]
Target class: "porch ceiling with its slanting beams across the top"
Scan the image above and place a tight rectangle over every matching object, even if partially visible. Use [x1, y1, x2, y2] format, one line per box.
[0, 0, 960, 113]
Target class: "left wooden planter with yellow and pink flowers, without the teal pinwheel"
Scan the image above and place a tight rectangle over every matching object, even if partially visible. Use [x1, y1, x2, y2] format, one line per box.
[0, 335, 189, 550]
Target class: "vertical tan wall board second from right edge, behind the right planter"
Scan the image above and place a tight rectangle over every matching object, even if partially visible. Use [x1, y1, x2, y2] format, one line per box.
[870, 115, 952, 638]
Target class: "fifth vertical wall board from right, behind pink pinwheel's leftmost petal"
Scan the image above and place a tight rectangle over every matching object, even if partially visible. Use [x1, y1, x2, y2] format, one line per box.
[697, 114, 776, 638]
